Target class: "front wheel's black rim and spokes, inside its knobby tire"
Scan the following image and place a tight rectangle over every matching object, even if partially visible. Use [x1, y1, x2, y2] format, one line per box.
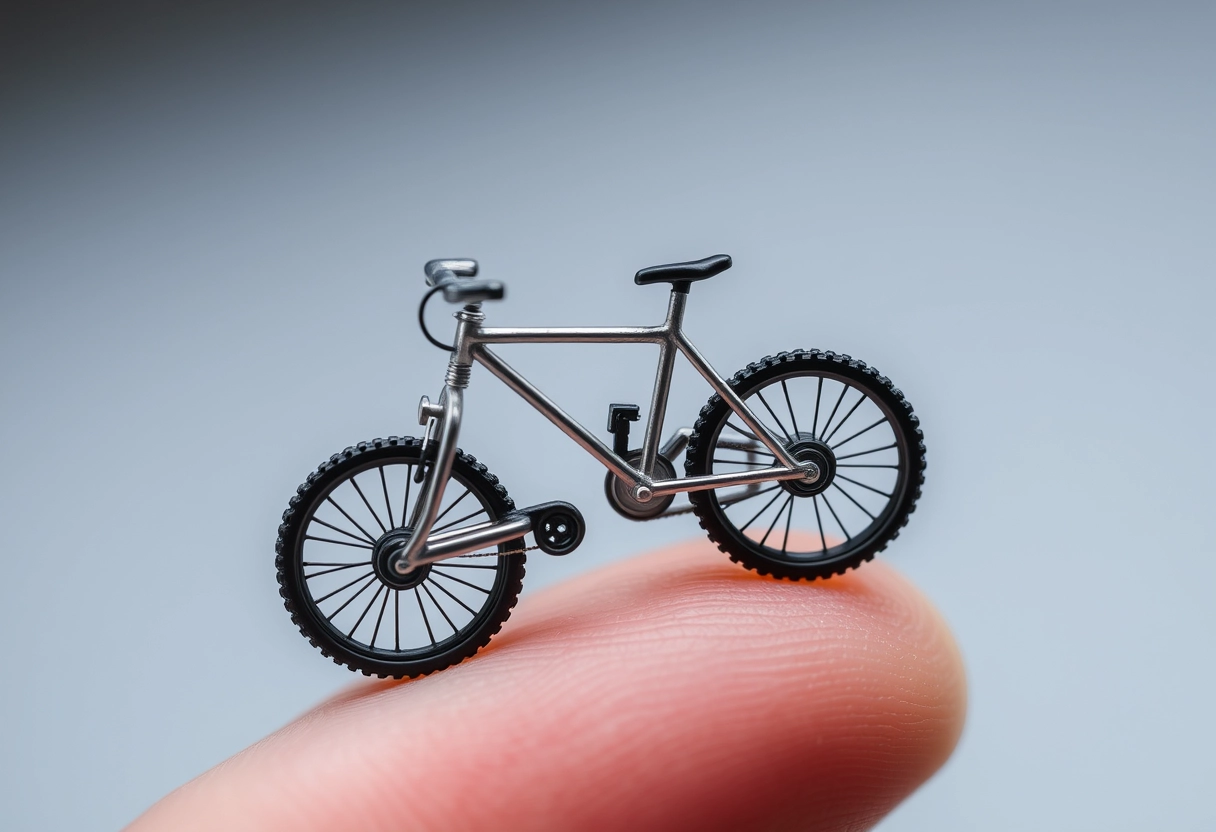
[295, 460, 507, 663]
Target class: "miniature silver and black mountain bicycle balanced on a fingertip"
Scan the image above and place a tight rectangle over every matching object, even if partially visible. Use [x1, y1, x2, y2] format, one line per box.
[275, 254, 925, 679]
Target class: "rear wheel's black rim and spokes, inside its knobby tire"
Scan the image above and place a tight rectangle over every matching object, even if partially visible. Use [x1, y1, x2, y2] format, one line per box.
[706, 369, 910, 564]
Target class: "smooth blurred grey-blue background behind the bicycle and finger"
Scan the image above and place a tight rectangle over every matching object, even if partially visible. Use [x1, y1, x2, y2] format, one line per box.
[0, 0, 1216, 832]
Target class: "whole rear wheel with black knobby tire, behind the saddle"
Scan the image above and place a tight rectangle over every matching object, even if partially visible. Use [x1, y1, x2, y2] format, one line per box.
[685, 350, 925, 580]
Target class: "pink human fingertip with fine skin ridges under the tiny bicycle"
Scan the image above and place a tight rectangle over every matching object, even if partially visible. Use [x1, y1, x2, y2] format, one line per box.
[129, 540, 966, 832]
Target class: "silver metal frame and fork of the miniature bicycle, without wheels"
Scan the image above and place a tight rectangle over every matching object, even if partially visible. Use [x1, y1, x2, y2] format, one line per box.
[401, 288, 818, 569]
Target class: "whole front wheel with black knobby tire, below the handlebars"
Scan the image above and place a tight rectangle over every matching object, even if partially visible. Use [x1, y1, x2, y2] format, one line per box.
[275, 437, 524, 679]
